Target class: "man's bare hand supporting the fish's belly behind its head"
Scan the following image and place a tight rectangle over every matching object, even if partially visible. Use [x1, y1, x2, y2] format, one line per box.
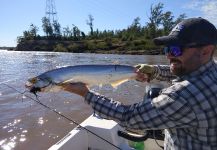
[60, 82, 89, 97]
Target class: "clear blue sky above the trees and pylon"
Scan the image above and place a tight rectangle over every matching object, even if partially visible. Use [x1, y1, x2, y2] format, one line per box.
[0, 0, 217, 46]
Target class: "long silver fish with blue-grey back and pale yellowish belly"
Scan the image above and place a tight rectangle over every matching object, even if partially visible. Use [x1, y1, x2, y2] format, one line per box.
[26, 65, 137, 93]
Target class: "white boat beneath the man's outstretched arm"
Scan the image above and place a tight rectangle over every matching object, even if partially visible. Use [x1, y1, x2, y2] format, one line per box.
[49, 86, 163, 150]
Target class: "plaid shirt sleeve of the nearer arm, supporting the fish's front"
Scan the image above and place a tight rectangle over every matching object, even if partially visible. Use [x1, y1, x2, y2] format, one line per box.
[85, 84, 197, 130]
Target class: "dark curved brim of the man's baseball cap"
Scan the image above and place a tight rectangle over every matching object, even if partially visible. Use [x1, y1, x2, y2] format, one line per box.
[153, 35, 180, 45]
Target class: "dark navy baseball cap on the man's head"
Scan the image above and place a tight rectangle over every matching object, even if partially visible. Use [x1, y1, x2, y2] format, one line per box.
[153, 17, 217, 46]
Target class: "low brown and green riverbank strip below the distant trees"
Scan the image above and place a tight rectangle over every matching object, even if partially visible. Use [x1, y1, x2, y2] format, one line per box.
[15, 40, 162, 55]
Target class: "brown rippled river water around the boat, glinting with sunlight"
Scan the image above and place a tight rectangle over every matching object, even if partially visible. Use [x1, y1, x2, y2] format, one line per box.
[0, 50, 176, 150]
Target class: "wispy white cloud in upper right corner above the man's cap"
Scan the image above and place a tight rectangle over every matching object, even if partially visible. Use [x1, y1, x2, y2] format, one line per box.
[185, 0, 217, 26]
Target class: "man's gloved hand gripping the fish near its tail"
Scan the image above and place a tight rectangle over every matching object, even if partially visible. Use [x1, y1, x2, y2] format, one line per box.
[135, 64, 155, 82]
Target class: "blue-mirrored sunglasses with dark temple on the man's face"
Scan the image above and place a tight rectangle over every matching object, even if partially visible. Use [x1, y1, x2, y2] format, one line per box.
[163, 44, 207, 57]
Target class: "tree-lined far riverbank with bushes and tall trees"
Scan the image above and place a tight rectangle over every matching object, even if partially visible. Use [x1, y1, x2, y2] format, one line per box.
[15, 3, 186, 54]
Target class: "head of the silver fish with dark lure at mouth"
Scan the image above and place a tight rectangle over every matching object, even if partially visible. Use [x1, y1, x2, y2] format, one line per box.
[25, 77, 52, 93]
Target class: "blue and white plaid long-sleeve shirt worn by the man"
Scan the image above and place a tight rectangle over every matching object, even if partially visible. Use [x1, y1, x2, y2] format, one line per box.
[85, 60, 217, 150]
